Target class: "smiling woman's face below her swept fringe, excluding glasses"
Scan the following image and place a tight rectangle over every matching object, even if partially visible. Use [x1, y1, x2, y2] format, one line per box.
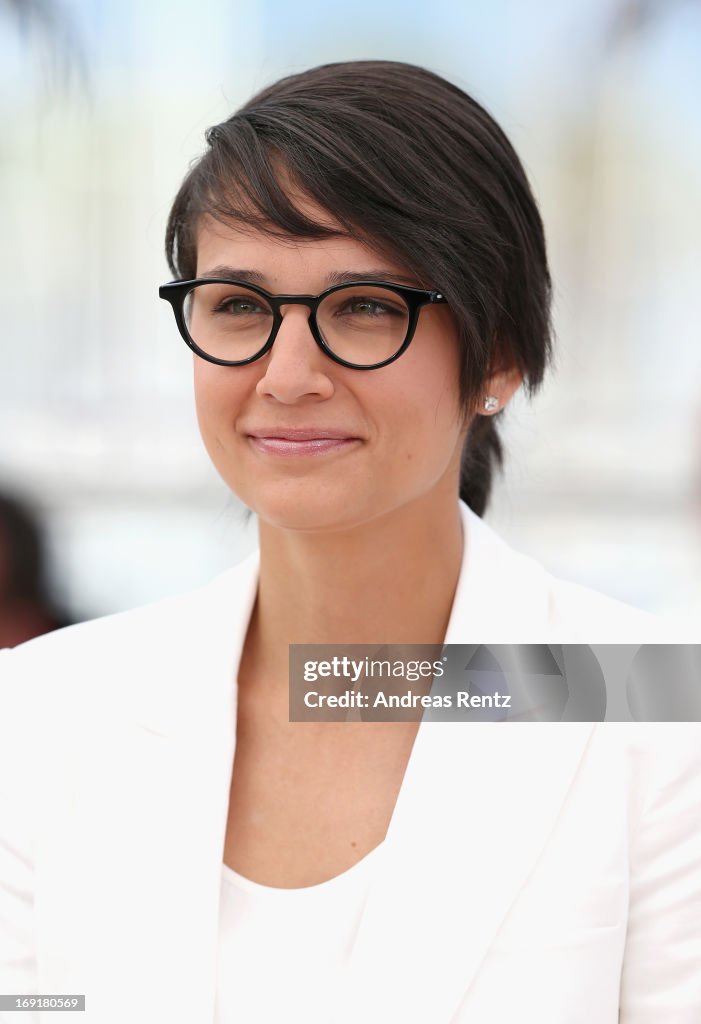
[194, 203, 465, 530]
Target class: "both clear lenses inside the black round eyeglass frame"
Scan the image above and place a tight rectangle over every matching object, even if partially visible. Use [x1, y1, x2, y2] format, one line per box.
[184, 284, 409, 367]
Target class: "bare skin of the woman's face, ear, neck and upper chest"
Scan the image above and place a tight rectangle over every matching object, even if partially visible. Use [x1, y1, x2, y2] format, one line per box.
[194, 197, 520, 888]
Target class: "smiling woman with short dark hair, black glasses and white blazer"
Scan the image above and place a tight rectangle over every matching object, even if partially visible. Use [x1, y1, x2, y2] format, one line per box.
[0, 61, 701, 1024]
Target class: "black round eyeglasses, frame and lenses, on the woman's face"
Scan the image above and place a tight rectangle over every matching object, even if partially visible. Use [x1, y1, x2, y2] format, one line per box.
[159, 278, 446, 370]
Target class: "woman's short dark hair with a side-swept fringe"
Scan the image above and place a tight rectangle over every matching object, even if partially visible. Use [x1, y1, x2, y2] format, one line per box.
[166, 60, 553, 515]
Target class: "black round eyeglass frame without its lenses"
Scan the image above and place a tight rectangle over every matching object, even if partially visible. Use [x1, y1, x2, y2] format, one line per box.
[159, 278, 447, 370]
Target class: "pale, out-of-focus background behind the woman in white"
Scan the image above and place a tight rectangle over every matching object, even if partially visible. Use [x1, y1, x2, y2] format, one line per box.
[0, 0, 701, 646]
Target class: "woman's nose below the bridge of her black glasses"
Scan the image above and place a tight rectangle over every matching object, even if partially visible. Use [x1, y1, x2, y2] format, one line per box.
[256, 304, 334, 404]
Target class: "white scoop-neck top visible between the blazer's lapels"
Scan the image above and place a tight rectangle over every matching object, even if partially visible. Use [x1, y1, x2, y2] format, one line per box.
[214, 844, 383, 1024]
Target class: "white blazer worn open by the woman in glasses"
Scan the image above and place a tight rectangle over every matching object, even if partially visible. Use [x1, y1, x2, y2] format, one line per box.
[0, 505, 701, 1024]
